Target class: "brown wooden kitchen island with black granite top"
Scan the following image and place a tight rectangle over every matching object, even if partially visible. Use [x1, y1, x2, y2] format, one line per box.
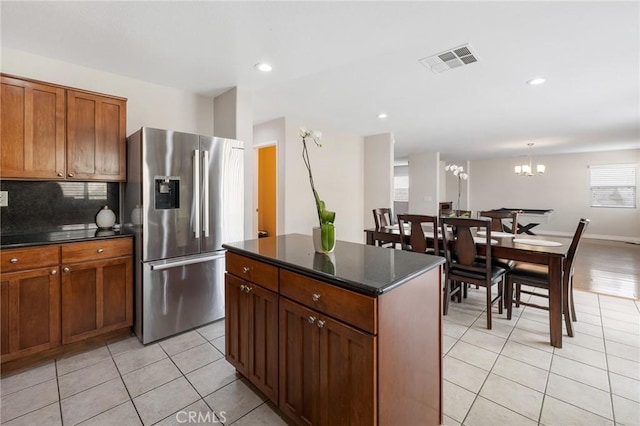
[224, 234, 444, 425]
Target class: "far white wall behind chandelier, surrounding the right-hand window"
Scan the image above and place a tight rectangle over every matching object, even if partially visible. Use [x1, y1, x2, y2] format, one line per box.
[470, 150, 640, 242]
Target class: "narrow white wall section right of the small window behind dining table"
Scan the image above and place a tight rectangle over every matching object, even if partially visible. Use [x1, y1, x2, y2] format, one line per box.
[409, 152, 440, 215]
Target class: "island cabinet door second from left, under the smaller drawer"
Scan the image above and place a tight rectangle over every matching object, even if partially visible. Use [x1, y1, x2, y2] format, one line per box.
[245, 283, 278, 404]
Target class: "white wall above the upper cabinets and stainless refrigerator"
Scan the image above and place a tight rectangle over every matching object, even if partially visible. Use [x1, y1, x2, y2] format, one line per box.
[1, 48, 213, 136]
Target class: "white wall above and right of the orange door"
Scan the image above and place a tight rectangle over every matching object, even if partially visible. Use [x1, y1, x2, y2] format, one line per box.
[253, 117, 286, 235]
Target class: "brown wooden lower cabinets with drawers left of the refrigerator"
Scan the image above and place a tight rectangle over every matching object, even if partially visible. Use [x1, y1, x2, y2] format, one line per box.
[0, 237, 133, 371]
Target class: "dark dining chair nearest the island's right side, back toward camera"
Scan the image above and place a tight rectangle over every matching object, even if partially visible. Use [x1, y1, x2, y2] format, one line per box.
[440, 217, 506, 330]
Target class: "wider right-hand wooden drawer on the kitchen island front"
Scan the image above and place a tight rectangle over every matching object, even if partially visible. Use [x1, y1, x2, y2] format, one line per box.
[280, 269, 377, 334]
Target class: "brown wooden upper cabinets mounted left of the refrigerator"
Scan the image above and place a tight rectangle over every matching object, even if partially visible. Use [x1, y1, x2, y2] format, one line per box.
[0, 75, 127, 182]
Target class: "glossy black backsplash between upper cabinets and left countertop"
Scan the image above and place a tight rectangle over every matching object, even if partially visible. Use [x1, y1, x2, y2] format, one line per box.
[0, 180, 120, 235]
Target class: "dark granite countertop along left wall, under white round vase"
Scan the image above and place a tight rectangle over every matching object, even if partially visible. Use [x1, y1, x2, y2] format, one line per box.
[0, 227, 134, 250]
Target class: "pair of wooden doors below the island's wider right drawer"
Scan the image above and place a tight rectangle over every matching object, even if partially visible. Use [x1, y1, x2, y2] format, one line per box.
[279, 298, 376, 425]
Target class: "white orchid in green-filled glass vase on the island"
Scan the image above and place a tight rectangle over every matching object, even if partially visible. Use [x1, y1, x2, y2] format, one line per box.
[298, 127, 336, 253]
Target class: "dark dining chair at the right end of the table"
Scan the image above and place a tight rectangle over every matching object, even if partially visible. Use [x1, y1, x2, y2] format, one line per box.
[505, 218, 589, 337]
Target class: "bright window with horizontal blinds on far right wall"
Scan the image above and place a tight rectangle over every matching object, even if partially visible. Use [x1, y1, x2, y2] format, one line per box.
[589, 164, 636, 208]
